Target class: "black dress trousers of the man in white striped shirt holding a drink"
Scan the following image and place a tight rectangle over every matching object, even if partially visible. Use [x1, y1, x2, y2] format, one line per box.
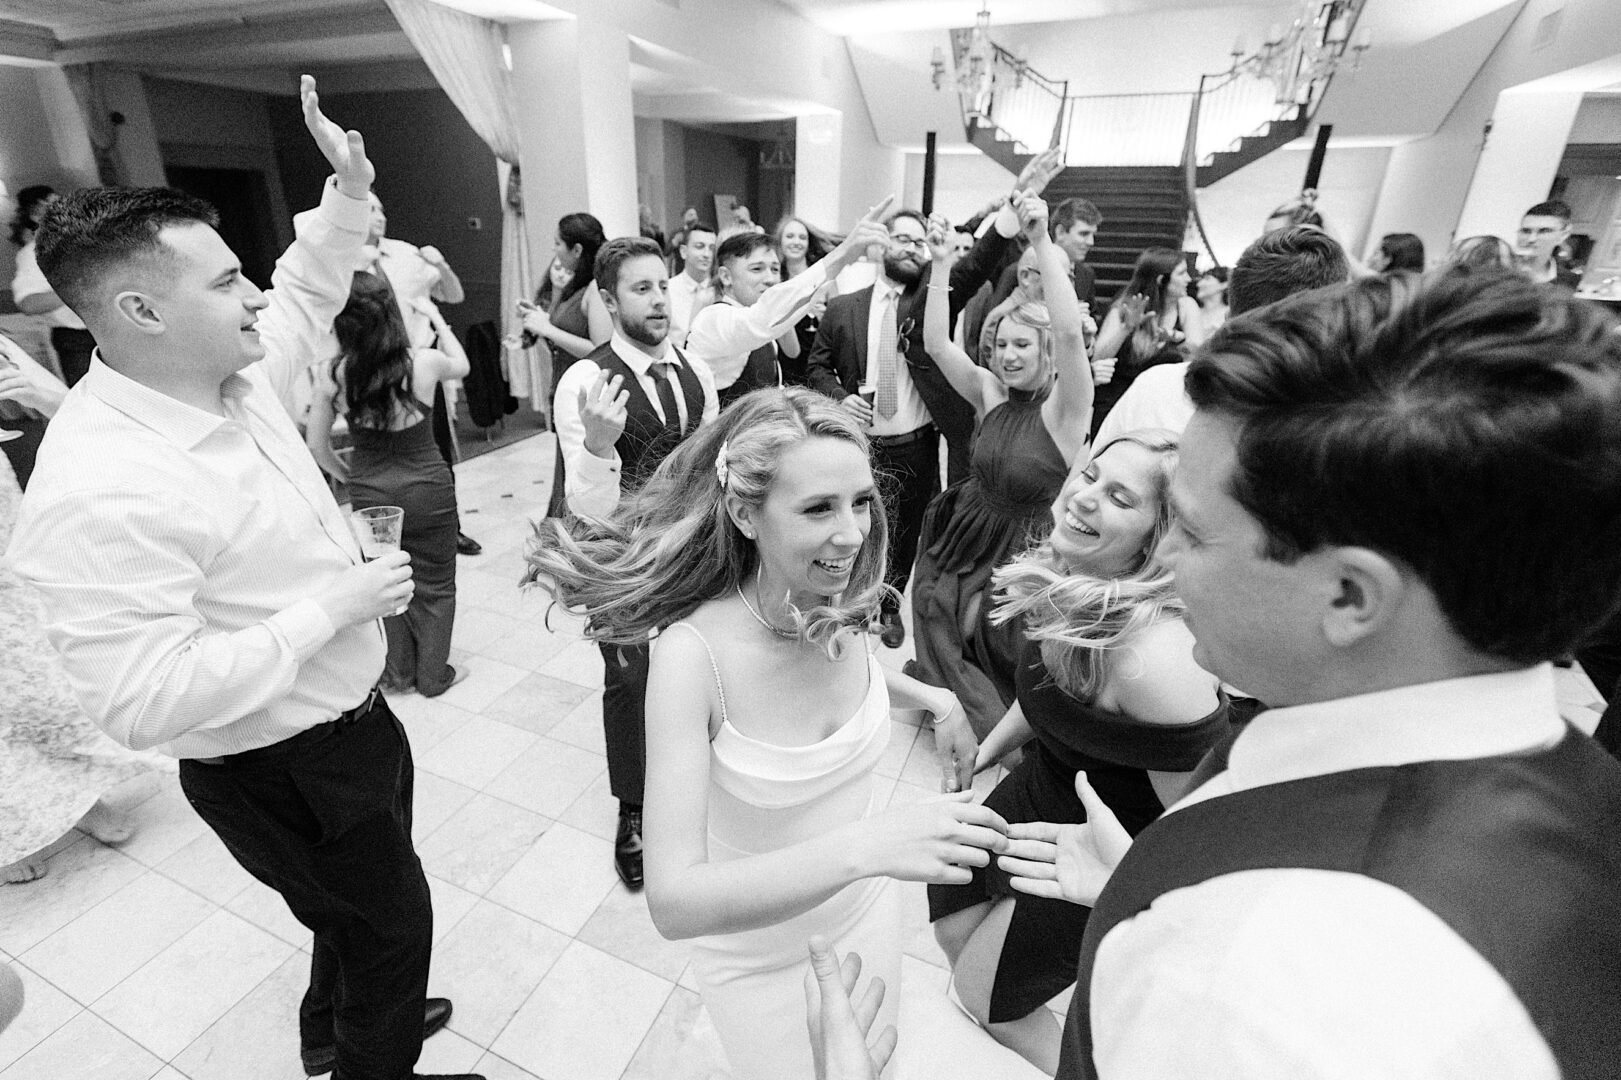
[180, 694, 433, 1080]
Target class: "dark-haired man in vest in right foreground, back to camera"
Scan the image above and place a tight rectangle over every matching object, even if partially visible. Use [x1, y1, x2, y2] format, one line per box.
[1059, 264, 1621, 1080]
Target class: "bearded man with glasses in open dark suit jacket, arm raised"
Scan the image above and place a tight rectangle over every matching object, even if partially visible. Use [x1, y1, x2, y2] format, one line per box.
[807, 198, 1018, 649]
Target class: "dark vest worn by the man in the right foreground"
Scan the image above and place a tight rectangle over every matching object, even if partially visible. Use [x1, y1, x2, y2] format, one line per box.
[1055, 730, 1621, 1080]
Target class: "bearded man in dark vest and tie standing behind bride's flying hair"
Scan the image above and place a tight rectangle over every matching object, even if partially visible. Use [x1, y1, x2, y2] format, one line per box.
[553, 237, 720, 890]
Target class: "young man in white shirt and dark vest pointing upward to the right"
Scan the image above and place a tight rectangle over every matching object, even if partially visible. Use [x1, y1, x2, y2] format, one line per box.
[687, 196, 893, 405]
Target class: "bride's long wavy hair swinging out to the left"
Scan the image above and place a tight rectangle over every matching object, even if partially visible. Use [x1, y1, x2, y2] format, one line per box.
[524, 386, 888, 658]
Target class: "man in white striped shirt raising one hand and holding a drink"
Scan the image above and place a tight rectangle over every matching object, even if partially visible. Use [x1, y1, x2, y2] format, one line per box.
[10, 76, 479, 1080]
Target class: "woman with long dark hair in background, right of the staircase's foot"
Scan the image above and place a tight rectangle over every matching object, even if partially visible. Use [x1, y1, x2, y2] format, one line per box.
[1093, 248, 1204, 438]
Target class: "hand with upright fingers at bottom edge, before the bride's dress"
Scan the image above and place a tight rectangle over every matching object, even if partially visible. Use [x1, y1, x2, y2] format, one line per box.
[806, 937, 896, 1080]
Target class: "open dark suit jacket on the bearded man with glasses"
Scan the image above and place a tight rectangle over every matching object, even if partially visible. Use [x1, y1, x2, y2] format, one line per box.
[806, 229, 1013, 443]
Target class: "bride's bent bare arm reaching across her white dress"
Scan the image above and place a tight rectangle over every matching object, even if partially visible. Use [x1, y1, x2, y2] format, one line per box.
[644, 628, 1007, 941]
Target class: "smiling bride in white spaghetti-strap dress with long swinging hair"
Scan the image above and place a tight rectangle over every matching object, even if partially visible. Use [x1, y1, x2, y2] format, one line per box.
[528, 388, 1007, 1080]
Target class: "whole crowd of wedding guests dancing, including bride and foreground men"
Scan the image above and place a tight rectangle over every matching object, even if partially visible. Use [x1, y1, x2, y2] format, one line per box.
[0, 78, 1621, 1080]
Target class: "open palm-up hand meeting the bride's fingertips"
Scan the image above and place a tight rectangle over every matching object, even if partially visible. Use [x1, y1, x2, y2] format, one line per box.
[997, 772, 1131, 908]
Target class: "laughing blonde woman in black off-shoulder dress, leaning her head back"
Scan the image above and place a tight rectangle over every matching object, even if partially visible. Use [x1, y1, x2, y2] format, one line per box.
[929, 431, 1227, 1074]
